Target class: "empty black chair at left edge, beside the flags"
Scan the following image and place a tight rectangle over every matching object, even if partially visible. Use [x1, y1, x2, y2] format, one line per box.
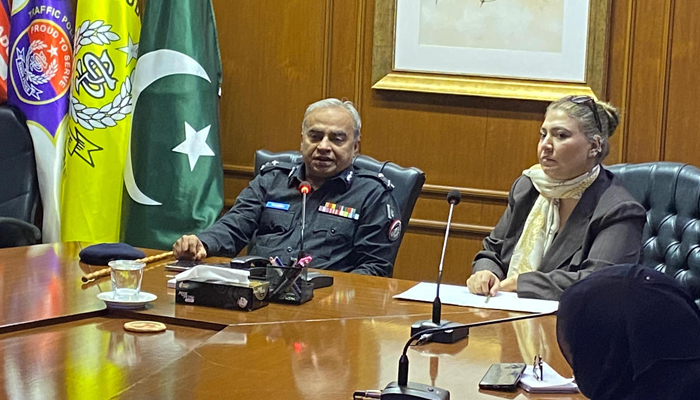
[0, 105, 41, 248]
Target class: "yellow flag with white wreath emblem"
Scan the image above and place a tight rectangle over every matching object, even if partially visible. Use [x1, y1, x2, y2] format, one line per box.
[61, 0, 141, 242]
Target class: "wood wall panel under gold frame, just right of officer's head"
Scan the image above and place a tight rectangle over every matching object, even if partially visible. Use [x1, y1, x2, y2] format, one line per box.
[362, 92, 487, 187]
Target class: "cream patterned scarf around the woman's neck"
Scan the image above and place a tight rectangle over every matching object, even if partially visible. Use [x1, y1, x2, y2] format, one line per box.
[508, 164, 600, 277]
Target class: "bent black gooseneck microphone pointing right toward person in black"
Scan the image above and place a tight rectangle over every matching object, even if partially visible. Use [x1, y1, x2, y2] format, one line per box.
[379, 312, 554, 400]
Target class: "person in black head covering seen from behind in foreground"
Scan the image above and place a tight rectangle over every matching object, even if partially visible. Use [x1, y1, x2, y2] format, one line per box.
[557, 265, 700, 400]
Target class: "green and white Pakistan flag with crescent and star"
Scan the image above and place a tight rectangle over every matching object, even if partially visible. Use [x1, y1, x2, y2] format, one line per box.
[122, 0, 223, 249]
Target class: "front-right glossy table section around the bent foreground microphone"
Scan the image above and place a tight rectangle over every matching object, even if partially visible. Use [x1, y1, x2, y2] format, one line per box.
[116, 316, 584, 399]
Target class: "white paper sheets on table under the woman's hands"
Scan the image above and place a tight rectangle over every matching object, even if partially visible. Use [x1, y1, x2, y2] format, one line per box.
[394, 282, 559, 313]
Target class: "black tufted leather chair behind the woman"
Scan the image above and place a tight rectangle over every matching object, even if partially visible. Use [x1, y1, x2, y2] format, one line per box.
[607, 162, 700, 304]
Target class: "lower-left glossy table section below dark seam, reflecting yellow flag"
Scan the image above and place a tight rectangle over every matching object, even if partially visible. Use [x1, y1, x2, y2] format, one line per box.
[0, 317, 216, 399]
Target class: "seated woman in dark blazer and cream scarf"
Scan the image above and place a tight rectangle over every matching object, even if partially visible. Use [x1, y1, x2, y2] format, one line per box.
[467, 96, 646, 300]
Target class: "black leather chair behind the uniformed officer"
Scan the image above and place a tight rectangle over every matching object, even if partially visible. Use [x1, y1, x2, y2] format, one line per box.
[255, 150, 425, 263]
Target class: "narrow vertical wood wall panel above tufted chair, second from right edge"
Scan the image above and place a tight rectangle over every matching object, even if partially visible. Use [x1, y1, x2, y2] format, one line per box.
[626, 0, 673, 163]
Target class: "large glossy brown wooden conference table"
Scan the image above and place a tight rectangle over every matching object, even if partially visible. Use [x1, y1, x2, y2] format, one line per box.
[0, 243, 584, 399]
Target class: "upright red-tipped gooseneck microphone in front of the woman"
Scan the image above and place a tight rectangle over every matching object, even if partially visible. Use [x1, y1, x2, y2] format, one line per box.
[411, 189, 469, 343]
